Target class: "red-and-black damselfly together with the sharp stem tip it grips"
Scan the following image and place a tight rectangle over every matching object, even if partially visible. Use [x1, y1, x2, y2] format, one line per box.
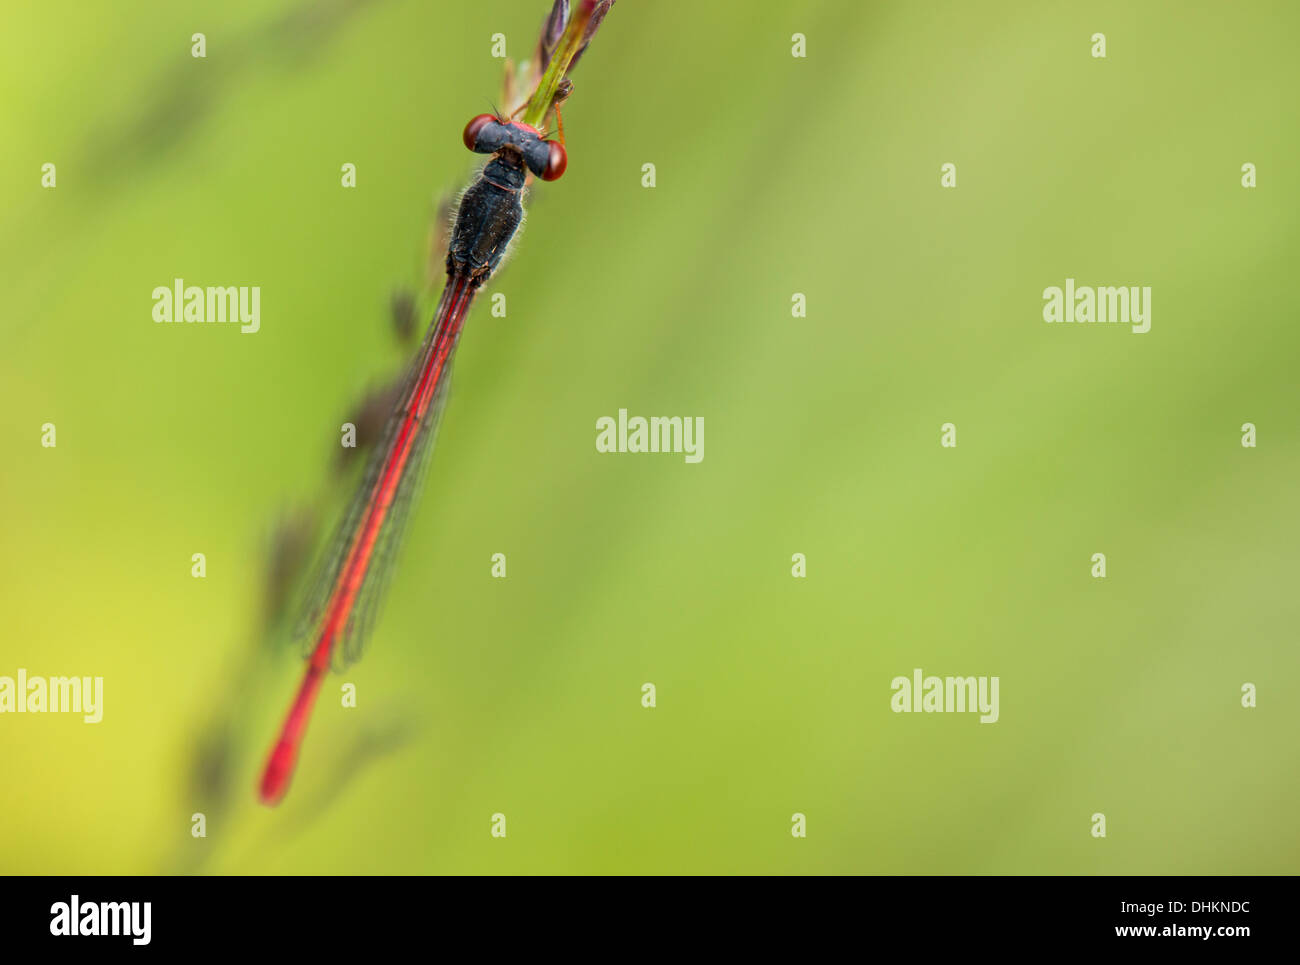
[260, 0, 614, 804]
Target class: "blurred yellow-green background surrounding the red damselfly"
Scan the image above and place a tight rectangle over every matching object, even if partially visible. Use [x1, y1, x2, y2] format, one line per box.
[0, 0, 1300, 874]
